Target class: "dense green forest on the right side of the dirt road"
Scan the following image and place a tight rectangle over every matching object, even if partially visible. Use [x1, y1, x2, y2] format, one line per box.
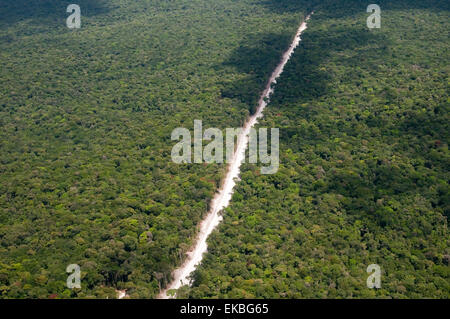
[184, 1, 450, 298]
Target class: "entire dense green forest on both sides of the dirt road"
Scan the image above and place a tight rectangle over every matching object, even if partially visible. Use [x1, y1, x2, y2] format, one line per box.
[0, 0, 450, 298]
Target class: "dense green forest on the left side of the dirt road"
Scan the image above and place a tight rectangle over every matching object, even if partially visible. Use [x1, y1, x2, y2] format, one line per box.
[0, 0, 310, 298]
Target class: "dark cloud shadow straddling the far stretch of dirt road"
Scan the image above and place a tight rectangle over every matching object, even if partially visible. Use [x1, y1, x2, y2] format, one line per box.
[222, 20, 389, 113]
